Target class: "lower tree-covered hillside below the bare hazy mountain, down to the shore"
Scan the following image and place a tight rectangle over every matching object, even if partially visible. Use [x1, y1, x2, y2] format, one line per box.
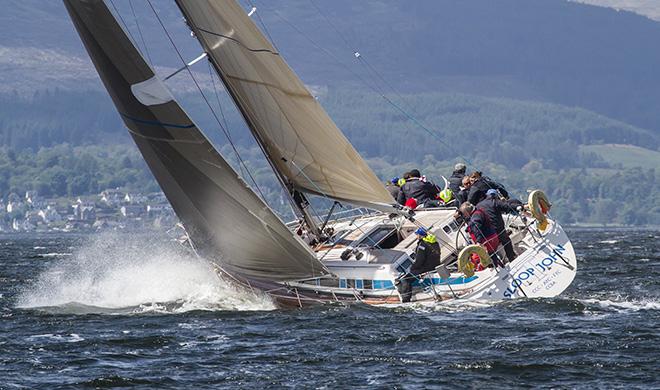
[0, 87, 660, 224]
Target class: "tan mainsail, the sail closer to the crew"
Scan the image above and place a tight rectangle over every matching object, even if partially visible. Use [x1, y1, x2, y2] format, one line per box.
[176, 0, 394, 210]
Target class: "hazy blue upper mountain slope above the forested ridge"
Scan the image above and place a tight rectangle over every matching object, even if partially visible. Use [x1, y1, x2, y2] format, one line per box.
[0, 0, 660, 131]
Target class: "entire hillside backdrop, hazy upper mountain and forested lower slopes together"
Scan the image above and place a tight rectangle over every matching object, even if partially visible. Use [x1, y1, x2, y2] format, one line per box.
[0, 0, 660, 224]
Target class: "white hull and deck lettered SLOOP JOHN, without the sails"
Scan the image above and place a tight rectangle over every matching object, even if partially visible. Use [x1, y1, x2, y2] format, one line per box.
[274, 210, 577, 305]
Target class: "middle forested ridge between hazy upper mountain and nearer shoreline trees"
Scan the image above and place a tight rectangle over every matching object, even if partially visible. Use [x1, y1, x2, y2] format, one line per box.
[0, 89, 660, 173]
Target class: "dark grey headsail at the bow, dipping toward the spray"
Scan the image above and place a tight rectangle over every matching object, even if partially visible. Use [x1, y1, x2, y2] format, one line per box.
[64, 0, 327, 280]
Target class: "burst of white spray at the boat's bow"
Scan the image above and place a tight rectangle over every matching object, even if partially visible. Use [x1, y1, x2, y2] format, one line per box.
[17, 233, 275, 313]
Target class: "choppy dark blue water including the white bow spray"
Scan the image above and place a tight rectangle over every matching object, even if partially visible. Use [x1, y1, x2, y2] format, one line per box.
[0, 231, 660, 388]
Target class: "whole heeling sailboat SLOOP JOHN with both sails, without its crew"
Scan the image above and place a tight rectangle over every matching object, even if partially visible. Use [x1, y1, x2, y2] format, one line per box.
[64, 0, 577, 306]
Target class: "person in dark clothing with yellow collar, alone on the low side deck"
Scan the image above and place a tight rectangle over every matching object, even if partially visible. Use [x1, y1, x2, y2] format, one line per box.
[397, 228, 440, 303]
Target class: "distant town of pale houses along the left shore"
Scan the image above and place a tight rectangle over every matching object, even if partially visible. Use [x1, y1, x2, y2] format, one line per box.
[0, 188, 178, 233]
